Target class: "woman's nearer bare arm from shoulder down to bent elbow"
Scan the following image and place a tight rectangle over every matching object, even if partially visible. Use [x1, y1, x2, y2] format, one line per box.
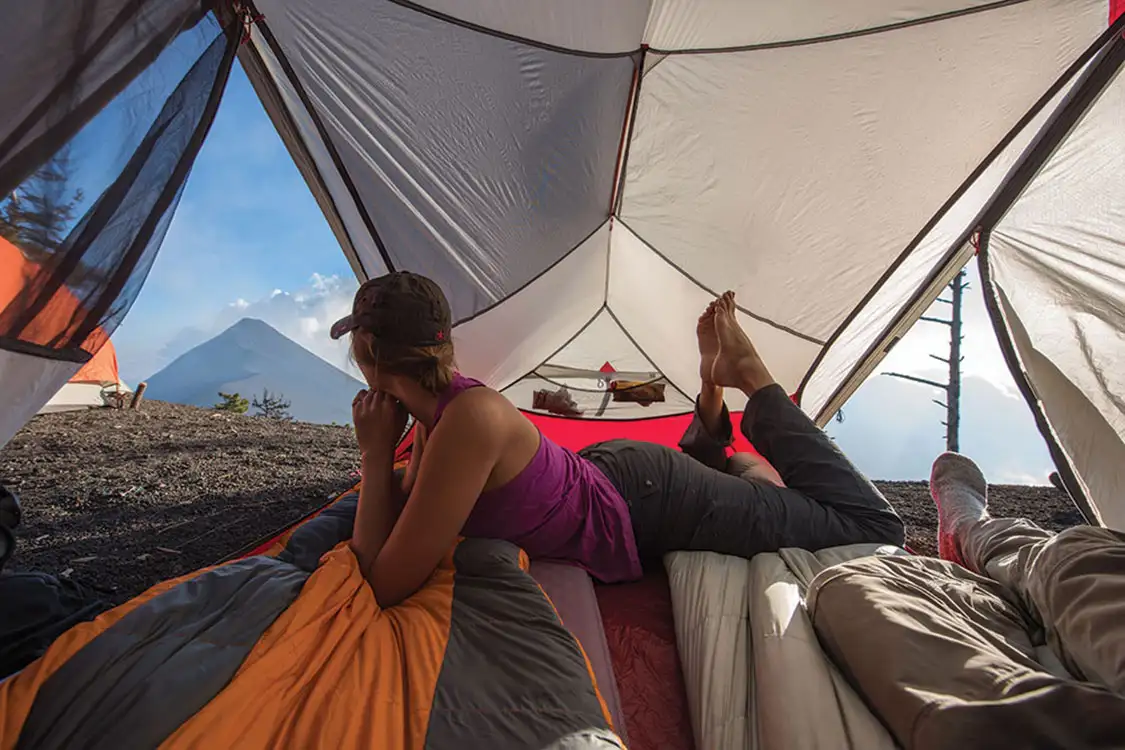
[353, 388, 505, 607]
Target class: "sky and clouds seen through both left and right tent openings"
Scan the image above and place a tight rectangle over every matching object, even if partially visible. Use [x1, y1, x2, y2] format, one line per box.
[107, 61, 1052, 484]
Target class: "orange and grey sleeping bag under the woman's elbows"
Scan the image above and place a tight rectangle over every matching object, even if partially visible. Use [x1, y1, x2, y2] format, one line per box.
[0, 491, 623, 750]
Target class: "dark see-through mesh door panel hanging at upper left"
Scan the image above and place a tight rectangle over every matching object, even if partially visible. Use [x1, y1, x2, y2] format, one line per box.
[0, 3, 239, 361]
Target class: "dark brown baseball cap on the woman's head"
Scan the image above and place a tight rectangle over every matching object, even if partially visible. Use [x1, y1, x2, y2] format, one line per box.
[331, 271, 452, 346]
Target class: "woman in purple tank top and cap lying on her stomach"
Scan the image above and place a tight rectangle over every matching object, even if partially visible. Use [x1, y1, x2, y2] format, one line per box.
[332, 272, 903, 607]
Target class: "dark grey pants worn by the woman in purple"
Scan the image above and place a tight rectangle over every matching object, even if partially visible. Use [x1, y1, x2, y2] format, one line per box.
[579, 386, 903, 559]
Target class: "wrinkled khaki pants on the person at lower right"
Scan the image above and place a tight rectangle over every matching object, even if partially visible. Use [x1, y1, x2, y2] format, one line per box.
[808, 518, 1125, 750]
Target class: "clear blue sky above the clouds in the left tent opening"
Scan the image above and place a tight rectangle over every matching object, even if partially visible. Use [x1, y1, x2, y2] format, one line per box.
[114, 61, 354, 382]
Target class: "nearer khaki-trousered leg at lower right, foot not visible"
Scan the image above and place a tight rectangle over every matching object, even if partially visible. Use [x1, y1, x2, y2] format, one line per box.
[808, 557, 1125, 750]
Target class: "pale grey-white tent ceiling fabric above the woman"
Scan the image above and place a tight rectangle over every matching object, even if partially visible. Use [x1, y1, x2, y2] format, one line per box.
[241, 0, 1107, 417]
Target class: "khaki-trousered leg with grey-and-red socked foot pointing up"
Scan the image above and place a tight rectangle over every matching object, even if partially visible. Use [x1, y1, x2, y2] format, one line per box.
[930, 453, 1125, 695]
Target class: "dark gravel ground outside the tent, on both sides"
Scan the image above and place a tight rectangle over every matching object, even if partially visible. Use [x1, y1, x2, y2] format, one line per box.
[0, 401, 1082, 602]
